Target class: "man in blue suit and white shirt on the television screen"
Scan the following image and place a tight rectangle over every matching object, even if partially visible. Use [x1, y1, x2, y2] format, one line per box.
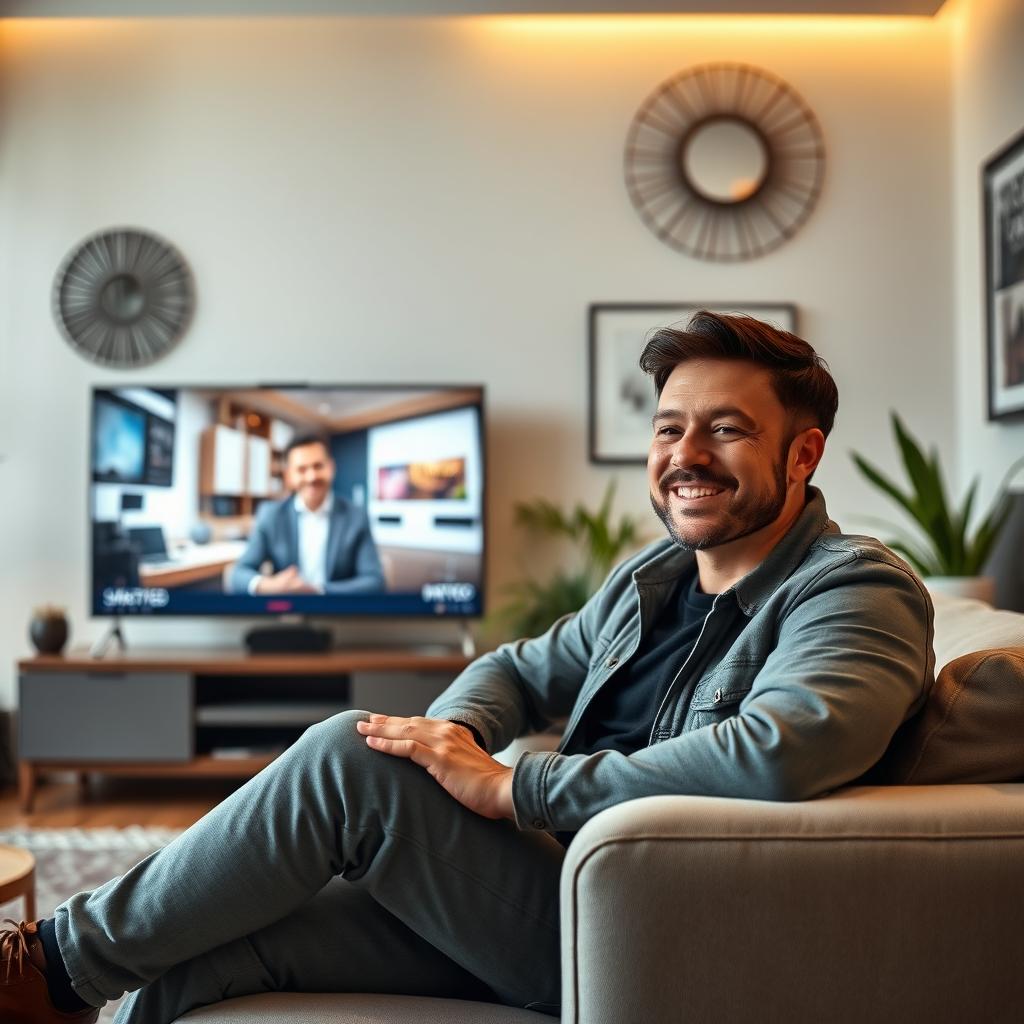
[228, 436, 385, 594]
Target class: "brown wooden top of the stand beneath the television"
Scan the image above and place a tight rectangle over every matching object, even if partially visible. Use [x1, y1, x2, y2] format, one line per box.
[17, 647, 472, 676]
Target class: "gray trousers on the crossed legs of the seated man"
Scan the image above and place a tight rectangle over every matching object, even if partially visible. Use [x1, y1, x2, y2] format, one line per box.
[55, 712, 564, 1024]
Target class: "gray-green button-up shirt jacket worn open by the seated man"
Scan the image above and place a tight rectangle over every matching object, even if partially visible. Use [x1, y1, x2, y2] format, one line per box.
[427, 487, 935, 831]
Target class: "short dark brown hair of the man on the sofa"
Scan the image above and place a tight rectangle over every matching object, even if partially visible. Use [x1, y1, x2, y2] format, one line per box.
[640, 309, 839, 437]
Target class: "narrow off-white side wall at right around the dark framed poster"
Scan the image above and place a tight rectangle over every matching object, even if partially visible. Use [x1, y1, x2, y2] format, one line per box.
[942, 0, 1024, 507]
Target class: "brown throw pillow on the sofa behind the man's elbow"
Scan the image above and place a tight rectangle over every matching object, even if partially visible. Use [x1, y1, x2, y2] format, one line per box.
[870, 647, 1024, 785]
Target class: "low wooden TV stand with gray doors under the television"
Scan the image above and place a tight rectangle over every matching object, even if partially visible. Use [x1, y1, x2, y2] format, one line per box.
[17, 647, 471, 813]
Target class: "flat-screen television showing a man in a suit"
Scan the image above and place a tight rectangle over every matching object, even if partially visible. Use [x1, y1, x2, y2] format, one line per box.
[89, 384, 484, 616]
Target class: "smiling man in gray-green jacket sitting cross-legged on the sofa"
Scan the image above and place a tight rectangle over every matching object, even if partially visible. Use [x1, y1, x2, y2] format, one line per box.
[0, 312, 933, 1024]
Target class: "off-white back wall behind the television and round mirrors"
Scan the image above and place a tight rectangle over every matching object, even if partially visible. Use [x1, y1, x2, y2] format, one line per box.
[0, 17, 958, 703]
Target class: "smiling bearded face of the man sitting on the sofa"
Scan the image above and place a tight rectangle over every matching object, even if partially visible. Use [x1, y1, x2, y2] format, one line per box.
[647, 359, 794, 550]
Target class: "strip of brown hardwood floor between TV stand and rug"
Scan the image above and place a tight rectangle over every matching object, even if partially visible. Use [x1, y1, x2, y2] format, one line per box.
[0, 775, 241, 828]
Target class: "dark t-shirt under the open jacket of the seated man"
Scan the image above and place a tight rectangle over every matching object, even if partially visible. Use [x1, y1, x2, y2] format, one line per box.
[562, 571, 715, 754]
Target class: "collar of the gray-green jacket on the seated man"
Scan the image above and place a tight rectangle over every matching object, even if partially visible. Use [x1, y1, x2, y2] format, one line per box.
[633, 486, 839, 616]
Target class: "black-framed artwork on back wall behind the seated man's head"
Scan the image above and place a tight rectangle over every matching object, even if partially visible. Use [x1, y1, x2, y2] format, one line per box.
[589, 302, 797, 466]
